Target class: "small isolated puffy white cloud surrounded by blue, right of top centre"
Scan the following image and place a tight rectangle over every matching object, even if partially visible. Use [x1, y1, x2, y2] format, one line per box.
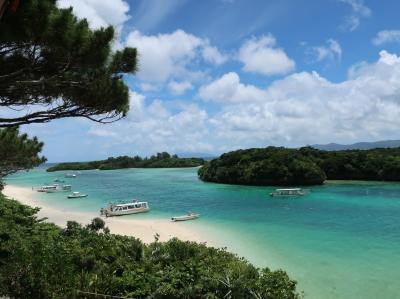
[239, 34, 295, 75]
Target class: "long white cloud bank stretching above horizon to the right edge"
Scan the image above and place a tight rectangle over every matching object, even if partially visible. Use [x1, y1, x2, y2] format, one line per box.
[90, 51, 400, 153]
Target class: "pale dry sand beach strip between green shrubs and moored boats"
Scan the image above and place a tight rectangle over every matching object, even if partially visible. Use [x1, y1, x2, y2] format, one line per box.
[3, 185, 211, 244]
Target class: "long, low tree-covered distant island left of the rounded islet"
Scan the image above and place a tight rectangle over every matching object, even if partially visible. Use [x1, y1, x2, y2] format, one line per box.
[47, 152, 205, 172]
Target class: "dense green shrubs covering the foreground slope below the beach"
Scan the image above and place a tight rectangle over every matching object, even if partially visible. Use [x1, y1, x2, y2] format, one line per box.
[0, 194, 300, 299]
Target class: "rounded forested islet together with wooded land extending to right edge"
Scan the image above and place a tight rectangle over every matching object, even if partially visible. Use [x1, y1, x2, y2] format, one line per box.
[198, 147, 400, 186]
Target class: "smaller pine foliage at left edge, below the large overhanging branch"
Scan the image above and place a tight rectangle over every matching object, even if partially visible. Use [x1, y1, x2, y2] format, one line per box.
[0, 127, 46, 190]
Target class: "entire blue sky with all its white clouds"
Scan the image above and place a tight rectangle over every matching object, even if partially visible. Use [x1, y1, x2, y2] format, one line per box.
[12, 0, 400, 161]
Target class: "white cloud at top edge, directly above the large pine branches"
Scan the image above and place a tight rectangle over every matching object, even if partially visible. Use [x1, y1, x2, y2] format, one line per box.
[57, 0, 130, 32]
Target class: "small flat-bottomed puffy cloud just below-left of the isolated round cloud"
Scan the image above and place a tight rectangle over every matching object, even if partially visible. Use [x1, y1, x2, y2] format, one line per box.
[199, 72, 265, 103]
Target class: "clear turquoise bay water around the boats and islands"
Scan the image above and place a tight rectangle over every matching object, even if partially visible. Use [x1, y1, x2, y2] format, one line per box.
[7, 168, 400, 299]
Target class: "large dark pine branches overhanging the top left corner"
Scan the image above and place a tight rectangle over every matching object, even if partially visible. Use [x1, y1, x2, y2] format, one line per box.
[0, 0, 137, 127]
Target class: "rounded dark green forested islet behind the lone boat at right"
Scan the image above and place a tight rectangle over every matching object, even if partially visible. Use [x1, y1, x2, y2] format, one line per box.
[199, 147, 326, 185]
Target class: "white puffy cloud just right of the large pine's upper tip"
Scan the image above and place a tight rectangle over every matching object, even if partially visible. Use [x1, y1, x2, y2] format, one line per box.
[126, 30, 223, 82]
